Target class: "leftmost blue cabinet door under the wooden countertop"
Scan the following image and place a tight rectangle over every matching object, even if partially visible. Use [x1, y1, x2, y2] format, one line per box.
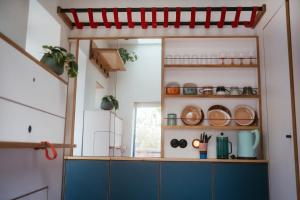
[64, 160, 109, 200]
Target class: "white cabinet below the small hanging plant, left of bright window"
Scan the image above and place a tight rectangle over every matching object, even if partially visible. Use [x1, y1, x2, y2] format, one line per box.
[83, 110, 123, 156]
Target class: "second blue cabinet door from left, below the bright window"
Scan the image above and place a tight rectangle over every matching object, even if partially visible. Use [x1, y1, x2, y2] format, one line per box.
[110, 161, 159, 200]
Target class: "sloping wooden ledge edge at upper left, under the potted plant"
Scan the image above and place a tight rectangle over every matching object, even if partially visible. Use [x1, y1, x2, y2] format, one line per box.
[0, 32, 68, 85]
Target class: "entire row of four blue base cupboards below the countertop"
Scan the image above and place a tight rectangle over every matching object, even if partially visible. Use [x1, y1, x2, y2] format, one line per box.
[64, 157, 269, 200]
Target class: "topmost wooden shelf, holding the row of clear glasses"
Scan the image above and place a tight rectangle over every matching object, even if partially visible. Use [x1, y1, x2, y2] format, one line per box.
[164, 64, 258, 68]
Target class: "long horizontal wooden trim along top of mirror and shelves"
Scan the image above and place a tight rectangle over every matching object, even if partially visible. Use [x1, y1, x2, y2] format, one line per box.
[68, 35, 258, 40]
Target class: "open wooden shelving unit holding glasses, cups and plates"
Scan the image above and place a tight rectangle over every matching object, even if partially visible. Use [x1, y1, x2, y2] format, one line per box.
[161, 36, 264, 159]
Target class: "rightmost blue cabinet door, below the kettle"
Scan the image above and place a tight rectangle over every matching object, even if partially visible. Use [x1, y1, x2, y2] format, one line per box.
[214, 163, 269, 200]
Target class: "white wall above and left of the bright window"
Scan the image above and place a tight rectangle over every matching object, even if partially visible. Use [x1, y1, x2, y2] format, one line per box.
[116, 44, 161, 156]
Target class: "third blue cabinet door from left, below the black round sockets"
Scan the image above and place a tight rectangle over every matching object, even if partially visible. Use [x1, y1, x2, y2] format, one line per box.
[160, 162, 212, 200]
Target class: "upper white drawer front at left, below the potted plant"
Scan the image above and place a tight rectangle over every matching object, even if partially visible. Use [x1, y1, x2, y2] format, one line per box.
[0, 40, 67, 117]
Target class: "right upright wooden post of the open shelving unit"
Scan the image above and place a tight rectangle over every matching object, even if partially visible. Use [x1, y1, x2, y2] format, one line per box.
[256, 37, 265, 159]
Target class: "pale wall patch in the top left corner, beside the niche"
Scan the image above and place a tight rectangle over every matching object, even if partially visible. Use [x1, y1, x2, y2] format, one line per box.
[0, 0, 29, 48]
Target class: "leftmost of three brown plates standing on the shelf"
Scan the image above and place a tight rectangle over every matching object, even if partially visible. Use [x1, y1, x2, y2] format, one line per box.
[180, 105, 204, 126]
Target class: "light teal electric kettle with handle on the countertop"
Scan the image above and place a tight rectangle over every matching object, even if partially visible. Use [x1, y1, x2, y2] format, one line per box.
[237, 130, 260, 159]
